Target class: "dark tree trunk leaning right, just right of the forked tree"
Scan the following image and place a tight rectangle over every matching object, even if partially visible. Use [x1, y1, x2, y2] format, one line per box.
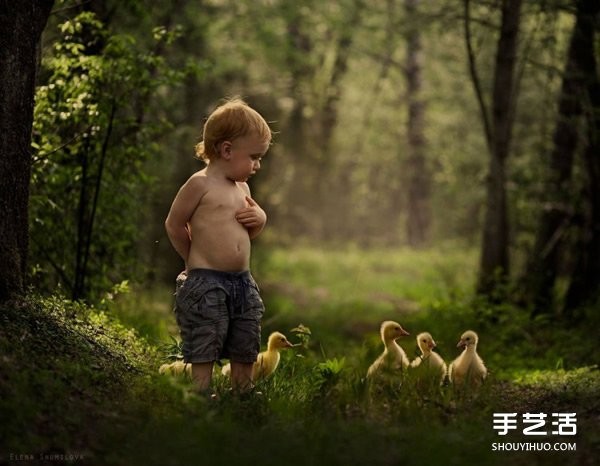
[524, 0, 597, 316]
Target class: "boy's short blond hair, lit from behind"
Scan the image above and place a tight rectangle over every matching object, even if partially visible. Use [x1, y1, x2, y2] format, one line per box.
[196, 97, 273, 163]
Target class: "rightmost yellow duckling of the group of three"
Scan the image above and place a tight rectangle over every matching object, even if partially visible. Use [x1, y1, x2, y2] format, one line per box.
[448, 330, 487, 388]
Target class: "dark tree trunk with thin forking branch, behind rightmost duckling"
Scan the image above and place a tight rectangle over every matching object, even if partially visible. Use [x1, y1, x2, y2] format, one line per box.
[465, 0, 522, 296]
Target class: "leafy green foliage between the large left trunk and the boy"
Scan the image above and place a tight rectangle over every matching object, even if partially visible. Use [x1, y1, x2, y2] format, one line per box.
[30, 13, 183, 301]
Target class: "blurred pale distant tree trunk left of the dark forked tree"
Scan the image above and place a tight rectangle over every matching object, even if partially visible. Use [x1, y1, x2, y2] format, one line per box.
[404, 0, 431, 247]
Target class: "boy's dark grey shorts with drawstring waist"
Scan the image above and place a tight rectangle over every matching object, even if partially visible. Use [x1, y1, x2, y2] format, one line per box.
[175, 269, 265, 363]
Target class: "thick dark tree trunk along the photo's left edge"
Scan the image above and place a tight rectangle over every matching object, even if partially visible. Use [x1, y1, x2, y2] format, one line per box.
[0, 0, 54, 301]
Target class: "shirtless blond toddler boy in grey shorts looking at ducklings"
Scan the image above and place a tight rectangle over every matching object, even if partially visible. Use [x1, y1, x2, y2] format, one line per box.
[165, 99, 272, 391]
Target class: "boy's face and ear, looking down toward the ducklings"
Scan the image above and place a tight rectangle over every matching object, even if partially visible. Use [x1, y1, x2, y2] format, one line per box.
[224, 135, 269, 182]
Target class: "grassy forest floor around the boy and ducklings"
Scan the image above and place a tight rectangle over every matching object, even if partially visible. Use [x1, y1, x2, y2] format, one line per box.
[0, 246, 600, 465]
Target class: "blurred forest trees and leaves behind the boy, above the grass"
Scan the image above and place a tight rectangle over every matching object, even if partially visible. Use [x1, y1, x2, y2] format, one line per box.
[14, 1, 598, 312]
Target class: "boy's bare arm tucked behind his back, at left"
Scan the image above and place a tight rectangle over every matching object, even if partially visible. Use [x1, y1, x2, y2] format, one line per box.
[165, 176, 204, 270]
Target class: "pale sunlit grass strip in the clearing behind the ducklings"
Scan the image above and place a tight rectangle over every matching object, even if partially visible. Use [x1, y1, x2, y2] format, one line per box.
[254, 242, 477, 309]
